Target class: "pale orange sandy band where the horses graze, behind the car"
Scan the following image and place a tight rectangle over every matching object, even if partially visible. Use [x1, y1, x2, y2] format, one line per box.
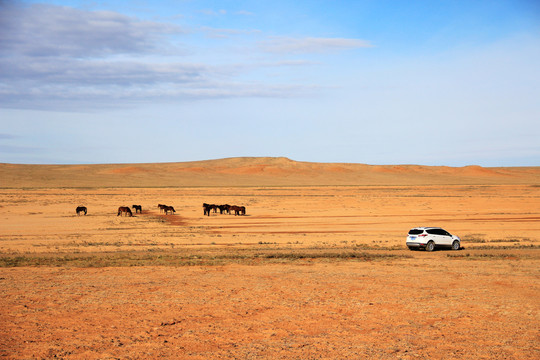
[0, 185, 540, 254]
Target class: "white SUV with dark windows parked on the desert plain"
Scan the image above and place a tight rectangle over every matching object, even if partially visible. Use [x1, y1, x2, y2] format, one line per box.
[407, 227, 461, 251]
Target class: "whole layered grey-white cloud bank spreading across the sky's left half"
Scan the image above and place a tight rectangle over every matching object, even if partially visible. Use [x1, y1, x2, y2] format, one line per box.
[0, 5, 316, 110]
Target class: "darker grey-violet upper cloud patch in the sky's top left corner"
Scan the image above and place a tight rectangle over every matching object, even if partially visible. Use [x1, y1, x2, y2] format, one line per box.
[0, 4, 184, 58]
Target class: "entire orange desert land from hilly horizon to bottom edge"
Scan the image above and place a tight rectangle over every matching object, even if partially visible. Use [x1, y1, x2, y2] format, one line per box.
[0, 158, 540, 359]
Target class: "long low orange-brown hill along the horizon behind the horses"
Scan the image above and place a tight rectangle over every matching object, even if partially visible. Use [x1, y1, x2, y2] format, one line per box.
[0, 157, 540, 188]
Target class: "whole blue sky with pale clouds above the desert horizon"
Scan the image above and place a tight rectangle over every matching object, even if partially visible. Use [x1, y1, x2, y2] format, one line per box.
[0, 0, 540, 166]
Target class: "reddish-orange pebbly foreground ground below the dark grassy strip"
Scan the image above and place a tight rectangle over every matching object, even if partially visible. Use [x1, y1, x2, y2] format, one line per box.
[0, 255, 540, 359]
